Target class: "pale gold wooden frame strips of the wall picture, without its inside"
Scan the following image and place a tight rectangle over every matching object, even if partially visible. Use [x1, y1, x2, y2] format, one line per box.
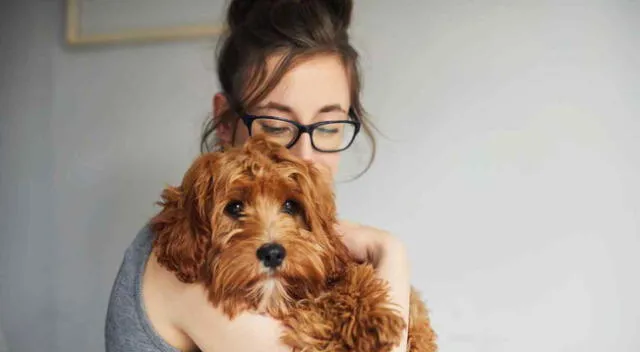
[65, 0, 224, 45]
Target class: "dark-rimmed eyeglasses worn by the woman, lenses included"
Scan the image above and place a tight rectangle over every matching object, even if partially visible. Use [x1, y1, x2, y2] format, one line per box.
[241, 112, 360, 153]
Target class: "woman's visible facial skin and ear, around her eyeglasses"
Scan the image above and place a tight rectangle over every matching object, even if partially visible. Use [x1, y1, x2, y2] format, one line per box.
[214, 55, 351, 180]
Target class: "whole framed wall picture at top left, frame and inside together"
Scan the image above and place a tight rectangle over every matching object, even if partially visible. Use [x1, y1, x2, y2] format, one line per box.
[65, 0, 224, 46]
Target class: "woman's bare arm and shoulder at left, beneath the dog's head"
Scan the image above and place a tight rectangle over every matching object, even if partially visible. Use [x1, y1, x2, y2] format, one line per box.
[143, 255, 291, 352]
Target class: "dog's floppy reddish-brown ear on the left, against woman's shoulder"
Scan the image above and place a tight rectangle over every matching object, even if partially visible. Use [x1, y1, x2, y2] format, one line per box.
[150, 153, 219, 283]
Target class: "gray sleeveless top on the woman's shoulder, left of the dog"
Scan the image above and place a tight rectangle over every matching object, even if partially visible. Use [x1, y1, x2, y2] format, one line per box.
[105, 226, 179, 352]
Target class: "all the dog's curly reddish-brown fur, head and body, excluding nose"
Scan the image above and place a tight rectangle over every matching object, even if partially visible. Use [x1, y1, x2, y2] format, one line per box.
[151, 137, 437, 352]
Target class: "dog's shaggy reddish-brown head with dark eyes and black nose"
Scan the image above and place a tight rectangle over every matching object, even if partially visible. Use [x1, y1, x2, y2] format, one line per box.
[151, 137, 349, 315]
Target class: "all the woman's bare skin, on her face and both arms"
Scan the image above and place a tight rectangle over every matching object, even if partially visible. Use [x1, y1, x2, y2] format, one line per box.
[143, 56, 410, 352]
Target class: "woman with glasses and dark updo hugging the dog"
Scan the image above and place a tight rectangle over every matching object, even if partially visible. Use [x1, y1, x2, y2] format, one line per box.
[105, 0, 410, 352]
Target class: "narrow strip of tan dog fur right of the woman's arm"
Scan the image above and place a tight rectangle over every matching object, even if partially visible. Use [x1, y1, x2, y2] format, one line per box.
[407, 287, 438, 352]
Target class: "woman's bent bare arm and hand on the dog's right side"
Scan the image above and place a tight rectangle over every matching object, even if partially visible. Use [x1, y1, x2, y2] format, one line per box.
[337, 221, 411, 352]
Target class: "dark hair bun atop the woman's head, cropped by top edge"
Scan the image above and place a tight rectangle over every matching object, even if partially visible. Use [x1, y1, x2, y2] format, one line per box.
[227, 0, 353, 30]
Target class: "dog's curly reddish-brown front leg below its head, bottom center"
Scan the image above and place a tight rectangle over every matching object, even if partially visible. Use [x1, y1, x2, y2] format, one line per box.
[283, 264, 406, 352]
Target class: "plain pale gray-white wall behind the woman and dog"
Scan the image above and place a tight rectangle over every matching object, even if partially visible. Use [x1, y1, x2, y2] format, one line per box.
[0, 0, 640, 352]
